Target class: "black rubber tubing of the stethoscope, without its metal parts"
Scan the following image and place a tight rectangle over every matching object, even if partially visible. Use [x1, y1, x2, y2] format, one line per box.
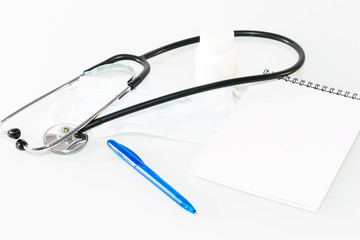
[79, 30, 305, 132]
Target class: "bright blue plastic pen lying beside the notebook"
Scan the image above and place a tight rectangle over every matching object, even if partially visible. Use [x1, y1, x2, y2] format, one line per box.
[107, 140, 196, 213]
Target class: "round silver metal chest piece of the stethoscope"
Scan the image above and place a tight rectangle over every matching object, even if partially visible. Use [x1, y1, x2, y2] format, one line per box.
[43, 124, 88, 154]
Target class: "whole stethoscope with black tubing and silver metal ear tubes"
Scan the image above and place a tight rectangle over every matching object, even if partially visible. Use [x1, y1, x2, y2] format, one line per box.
[0, 31, 305, 154]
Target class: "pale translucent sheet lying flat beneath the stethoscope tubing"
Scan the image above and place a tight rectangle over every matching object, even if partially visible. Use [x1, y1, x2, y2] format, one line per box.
[50, 76, 245, 144]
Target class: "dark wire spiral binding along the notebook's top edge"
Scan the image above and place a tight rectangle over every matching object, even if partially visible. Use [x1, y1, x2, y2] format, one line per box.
[263, 69, 360, 100]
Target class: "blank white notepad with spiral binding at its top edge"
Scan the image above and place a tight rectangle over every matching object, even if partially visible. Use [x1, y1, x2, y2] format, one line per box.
[191, 75, 360, 212]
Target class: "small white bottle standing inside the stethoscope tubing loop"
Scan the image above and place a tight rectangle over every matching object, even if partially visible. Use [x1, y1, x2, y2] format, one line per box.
[195, 25, 238, 86]
